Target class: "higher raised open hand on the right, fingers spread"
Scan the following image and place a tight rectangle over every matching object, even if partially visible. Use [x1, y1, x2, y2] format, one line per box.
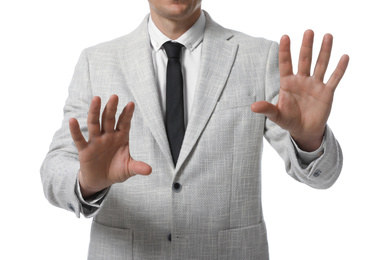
[252, 30, 349, 151]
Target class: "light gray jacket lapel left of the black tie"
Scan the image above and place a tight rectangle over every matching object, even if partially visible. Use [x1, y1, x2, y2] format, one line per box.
[118, 16, 173, 167]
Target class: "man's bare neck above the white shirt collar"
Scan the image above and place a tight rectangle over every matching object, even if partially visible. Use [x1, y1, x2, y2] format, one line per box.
[150, 8, 202, 40]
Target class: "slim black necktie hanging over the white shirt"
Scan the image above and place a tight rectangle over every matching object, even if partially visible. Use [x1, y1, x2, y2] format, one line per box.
[163, 42, 185, 166]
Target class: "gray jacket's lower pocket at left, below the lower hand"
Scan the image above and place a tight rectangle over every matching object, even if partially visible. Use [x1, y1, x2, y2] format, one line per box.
[88, 221, 133, 260]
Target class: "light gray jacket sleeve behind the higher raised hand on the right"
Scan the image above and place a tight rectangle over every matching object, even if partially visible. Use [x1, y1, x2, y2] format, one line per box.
[264, 43, 343, 189]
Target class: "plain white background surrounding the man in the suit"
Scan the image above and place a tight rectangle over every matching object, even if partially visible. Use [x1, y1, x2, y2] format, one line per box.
[0, 0, 390, 260]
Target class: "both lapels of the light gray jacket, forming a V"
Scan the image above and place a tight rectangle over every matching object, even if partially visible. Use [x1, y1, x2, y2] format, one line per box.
[118, 13, 238, 172]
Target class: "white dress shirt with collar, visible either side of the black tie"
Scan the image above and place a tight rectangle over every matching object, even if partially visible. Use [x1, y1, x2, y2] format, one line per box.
[148, 12, 206, 125]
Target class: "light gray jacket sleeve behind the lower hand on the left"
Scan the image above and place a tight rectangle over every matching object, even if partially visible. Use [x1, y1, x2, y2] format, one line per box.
[41, 50, 106, 217]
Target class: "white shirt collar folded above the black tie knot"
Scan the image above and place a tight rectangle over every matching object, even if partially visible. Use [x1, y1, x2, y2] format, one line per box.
[148, 12, 206, 51]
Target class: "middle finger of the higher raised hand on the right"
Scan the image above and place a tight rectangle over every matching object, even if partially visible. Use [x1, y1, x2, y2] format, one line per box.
[298, 30, 314, 76]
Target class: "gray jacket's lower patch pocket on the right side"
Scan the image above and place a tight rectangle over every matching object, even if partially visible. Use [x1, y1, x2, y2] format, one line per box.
[218, 222, 269, 260]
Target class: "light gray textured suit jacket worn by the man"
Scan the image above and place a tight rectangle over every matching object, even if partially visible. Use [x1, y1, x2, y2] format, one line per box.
[41, 14, 342, 260]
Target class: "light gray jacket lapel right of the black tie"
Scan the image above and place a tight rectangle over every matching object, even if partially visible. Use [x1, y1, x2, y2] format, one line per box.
[176, 13, 238, 173]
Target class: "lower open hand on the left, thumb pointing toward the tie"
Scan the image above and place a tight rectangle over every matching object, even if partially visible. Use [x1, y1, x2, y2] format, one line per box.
[69, 95, 152, 198]
